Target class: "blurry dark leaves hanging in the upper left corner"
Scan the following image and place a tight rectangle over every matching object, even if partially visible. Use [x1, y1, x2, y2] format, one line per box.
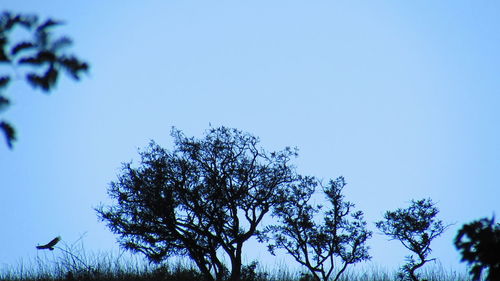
[0, 12, 88, 148]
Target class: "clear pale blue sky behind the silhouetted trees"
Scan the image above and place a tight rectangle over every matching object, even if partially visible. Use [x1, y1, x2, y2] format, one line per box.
[0, 0, 500, 274]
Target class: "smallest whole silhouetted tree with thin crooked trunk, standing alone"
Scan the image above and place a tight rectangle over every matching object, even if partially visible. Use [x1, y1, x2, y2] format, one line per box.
[376, 199, 448, 281]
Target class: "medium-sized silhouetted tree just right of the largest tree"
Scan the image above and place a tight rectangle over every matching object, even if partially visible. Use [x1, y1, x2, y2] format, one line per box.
[260, 177, 372, 281]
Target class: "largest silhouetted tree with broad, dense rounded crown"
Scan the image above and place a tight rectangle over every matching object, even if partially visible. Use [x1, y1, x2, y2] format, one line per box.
[97, 127, 296, 280]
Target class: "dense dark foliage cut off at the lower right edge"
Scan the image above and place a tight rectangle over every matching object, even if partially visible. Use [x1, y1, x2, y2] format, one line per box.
[455, 217, 500, 281]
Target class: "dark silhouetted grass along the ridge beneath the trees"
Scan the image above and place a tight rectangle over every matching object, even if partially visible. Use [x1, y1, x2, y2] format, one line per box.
[0, 241, 471, 281]
